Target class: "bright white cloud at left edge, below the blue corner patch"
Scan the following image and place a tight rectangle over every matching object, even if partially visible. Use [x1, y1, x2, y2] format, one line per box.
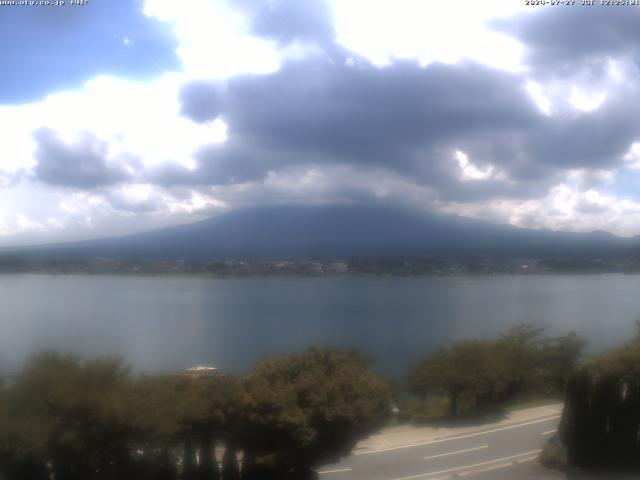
[0, 74, 226, 183]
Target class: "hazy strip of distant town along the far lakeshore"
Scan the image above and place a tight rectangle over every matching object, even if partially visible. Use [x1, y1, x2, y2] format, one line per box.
[0, 256, 640, 277]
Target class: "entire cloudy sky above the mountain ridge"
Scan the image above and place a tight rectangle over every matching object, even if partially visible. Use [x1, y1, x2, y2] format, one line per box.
[0, 0, 640, 245]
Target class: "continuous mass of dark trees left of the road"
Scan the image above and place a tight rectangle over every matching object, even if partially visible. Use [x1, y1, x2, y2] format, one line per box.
[0, 349, 390, 480]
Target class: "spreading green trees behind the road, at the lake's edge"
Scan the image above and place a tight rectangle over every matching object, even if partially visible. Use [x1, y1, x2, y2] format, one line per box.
[407, 325, 585, 416]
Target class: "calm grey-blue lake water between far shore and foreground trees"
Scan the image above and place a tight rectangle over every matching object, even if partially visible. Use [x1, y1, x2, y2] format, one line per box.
[0, 275, 640, 375]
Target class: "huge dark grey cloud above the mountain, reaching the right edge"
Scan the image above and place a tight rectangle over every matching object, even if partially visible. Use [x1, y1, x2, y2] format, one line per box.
[168, 50, 640, 201]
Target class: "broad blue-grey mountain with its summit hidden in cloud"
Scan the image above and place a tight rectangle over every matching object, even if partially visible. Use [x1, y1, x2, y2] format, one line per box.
[5, 206, 640, 260]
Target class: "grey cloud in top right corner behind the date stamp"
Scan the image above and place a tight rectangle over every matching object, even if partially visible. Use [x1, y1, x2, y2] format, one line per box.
[495, 6, 640, 76]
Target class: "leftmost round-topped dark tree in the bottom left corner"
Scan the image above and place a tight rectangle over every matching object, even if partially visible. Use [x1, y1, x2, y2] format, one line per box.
[3, 353, 139, 480]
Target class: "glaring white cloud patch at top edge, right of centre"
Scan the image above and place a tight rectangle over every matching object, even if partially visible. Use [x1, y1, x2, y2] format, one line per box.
[331, 0, 531, 71]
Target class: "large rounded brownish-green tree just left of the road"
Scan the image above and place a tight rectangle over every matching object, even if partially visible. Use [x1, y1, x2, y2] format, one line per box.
[239, 348, 390, 478]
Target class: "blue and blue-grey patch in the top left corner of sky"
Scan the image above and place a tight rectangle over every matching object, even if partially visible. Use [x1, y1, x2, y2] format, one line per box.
[0, 1, 179, 104]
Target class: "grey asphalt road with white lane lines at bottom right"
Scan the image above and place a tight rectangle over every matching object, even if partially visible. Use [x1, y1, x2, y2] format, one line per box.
[318, 415, 560, 480]
